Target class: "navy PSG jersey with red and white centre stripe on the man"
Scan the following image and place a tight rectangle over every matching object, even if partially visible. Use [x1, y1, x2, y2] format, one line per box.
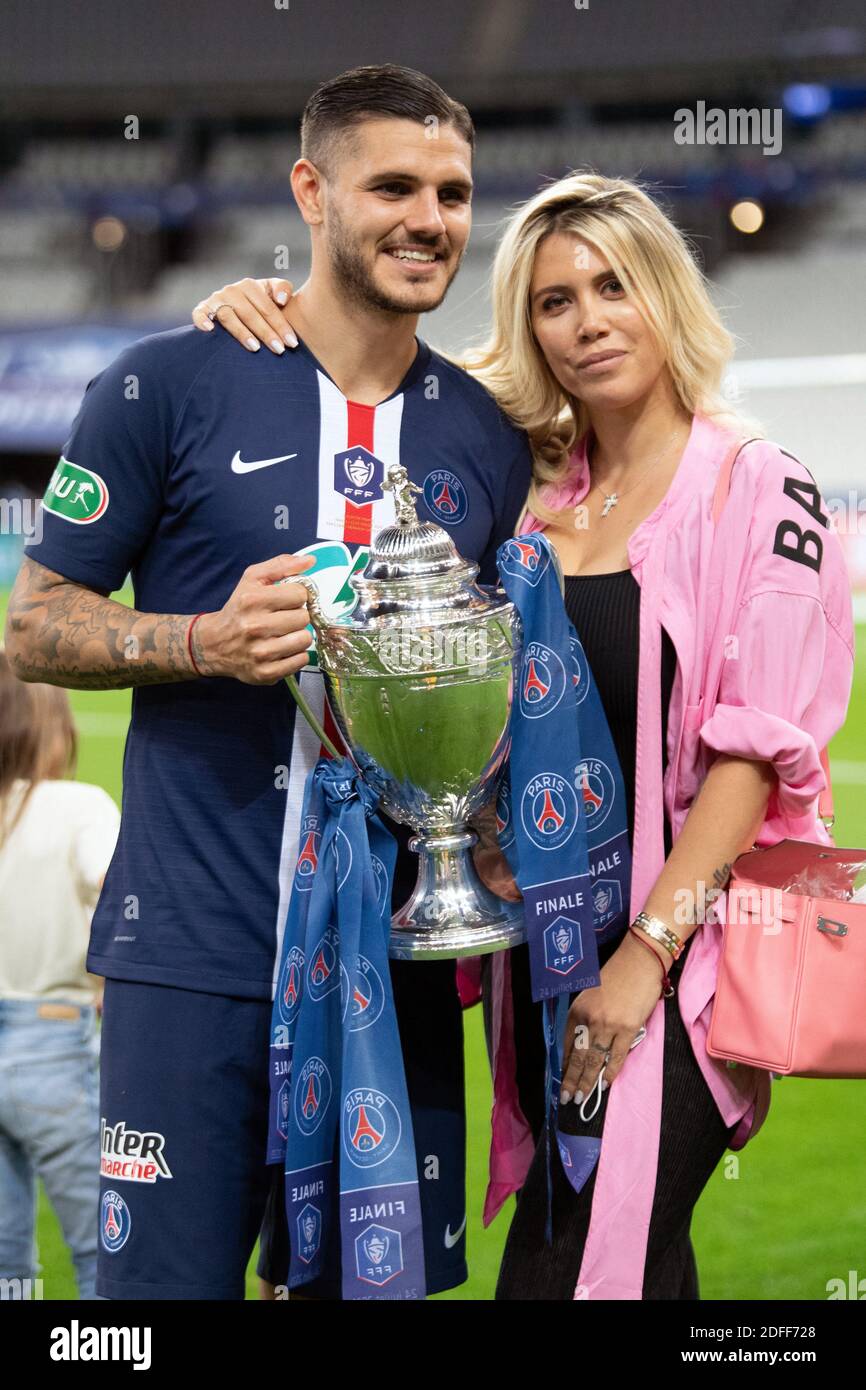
[26, 328, 531, 998]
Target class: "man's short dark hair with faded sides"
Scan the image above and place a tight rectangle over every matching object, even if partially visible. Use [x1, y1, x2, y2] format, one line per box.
[300, 63, 475, 175]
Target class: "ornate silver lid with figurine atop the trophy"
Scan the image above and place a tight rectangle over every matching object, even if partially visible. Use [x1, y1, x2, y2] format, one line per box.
[341, 464, 502, 627]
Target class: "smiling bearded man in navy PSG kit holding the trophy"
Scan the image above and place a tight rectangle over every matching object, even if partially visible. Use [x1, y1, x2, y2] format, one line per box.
[6, 67, 531, 1298]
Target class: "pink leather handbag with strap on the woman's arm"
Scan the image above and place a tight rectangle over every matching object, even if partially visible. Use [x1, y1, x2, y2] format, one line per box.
[706, 445, 866, 1077]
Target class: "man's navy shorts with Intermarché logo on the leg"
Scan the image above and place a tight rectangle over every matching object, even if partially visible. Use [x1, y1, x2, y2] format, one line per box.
[96, 960, 467, 1300]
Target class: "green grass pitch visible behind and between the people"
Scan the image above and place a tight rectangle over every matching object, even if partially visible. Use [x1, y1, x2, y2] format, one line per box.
[0, 581, 866, 1300]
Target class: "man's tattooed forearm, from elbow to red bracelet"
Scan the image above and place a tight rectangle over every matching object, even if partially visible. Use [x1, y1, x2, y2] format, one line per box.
[7, 557, 196, 689]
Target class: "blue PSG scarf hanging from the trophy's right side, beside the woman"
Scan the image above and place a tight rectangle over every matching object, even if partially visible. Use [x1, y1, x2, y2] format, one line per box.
[496, 532, 631, 1212]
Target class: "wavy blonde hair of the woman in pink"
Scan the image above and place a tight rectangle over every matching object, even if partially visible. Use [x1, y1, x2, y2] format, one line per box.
[459, 170, 762, 521]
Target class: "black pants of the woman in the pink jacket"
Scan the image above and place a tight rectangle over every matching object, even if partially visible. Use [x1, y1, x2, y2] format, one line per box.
[496, 945, 737, 1300]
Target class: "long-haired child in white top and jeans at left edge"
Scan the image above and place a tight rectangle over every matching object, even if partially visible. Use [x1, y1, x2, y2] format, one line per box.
[0, 648, 120, 1298]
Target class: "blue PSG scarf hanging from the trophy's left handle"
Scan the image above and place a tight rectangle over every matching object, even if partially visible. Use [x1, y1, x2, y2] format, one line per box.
[268, 758, 425, 1300]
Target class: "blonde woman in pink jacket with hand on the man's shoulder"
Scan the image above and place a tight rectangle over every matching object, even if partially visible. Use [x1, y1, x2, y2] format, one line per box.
[196, 172, 853, 1300]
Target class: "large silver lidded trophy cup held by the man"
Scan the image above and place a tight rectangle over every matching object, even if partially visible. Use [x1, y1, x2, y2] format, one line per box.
[300, 466, 525, 960]
